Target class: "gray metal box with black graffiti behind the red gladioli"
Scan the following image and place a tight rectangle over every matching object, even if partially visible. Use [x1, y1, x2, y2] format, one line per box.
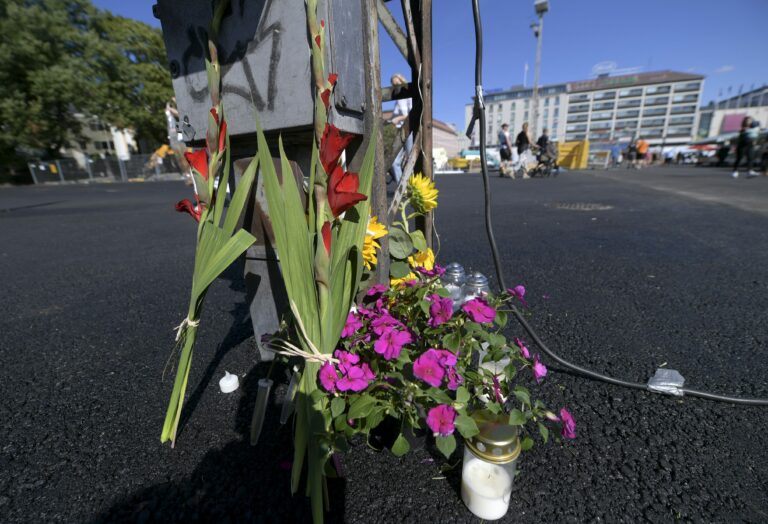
[154, 0, 367, 141]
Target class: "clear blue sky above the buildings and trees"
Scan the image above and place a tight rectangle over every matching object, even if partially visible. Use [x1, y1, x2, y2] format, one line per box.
[94, 0, 768, 128]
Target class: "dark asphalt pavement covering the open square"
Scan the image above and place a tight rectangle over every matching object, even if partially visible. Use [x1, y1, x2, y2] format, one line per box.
[0, 167, 768, 523]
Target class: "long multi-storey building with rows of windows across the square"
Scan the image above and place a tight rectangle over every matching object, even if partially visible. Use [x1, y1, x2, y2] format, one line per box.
[465, 71, 704, 145]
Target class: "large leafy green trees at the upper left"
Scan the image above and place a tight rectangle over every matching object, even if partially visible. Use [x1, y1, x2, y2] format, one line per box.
[0, 0, 173, 179]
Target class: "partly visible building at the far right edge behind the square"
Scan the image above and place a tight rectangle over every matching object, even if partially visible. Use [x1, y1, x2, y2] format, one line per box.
[697, 85, 768, 138]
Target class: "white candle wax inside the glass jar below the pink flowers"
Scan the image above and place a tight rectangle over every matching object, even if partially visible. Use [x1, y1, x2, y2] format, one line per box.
[461, 457, 512, 520]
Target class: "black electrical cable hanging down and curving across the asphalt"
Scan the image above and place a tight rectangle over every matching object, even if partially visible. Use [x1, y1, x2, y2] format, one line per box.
[467, 0, 768, 406]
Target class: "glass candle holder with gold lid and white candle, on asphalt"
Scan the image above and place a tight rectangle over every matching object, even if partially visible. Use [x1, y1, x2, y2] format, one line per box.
[461, 410, 520, 520]
